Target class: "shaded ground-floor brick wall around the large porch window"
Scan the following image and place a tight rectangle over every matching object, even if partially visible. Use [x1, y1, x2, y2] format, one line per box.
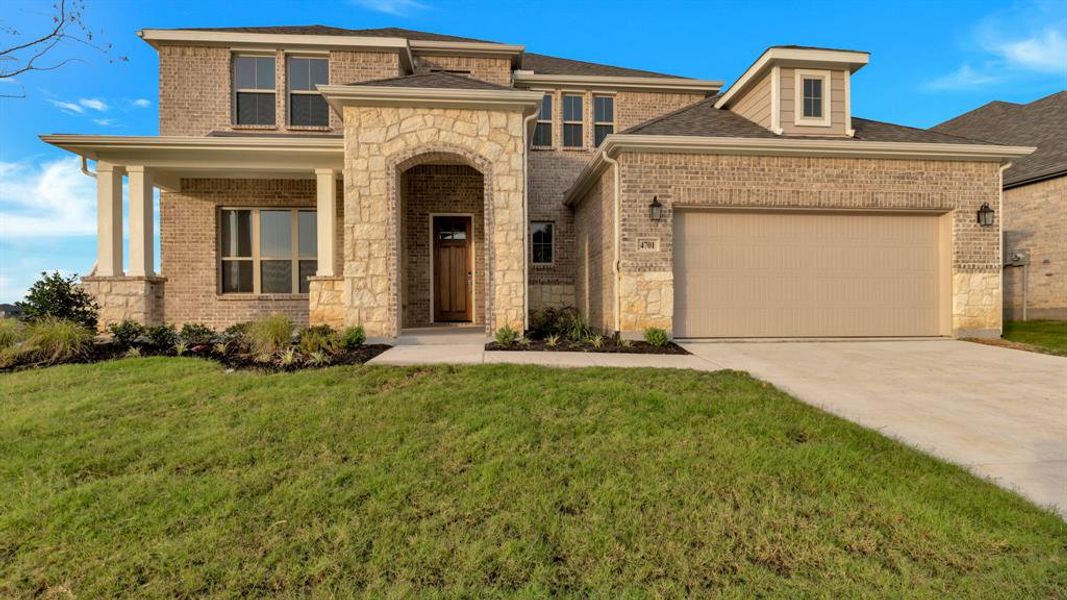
[159, 179, 344, 329]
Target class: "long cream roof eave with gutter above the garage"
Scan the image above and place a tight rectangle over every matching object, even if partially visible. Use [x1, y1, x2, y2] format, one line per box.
[563, 133, 1037, 206]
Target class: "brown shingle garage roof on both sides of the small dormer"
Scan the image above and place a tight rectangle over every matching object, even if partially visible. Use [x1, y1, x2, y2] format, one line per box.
[622, 96, 987, 144]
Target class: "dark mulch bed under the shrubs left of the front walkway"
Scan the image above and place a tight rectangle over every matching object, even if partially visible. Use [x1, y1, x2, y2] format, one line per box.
[0, 342, 392, 373]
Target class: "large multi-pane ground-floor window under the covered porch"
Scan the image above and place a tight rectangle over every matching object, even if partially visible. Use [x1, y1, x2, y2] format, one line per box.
[219, 208, 318, 294]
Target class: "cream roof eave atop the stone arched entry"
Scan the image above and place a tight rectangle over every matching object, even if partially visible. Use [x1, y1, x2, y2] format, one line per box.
[318, 85, 543, 114]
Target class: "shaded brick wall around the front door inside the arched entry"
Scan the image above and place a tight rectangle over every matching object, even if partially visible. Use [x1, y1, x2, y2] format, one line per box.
[400, 164, 489, 327]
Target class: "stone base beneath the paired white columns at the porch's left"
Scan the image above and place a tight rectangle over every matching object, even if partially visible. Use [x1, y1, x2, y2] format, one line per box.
[81, 275, 166, 332]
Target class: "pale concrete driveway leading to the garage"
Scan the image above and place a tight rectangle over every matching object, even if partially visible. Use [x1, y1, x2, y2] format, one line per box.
[683, 340, 1067, 517]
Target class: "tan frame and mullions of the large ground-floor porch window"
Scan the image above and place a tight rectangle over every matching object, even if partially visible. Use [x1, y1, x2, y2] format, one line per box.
[216, 205, 319, 298]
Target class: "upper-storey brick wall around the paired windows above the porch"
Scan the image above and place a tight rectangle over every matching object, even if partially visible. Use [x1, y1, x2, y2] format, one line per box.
[159, 45, 400, 136]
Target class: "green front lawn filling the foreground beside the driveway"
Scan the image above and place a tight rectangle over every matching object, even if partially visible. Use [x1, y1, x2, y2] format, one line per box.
[0, 358, 1067, 598]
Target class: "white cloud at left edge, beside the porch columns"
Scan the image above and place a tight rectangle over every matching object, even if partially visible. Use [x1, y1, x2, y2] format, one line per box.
[0, 157, 96, 239]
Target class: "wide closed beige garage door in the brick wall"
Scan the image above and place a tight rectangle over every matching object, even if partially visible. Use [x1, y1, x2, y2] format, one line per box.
[673, 211, 946, 337]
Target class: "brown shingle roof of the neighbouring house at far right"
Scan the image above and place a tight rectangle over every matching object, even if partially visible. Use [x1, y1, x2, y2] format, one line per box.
[931, 91, 1067, 187]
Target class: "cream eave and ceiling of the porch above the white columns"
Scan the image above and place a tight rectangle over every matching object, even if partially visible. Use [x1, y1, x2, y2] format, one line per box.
[41, 133, 345, 189]
